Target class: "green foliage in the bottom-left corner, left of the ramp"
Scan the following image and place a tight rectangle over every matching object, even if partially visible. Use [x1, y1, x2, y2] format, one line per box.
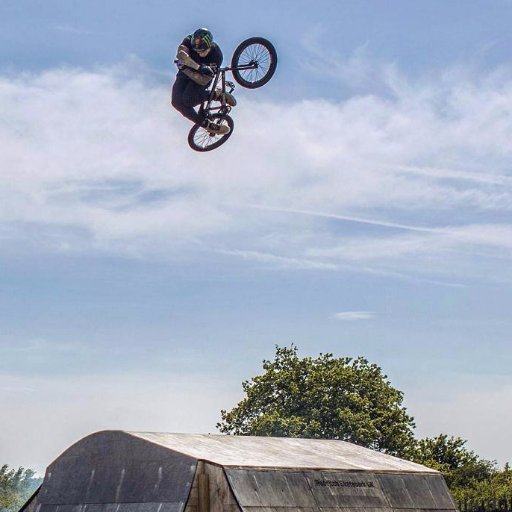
[0, 464, 41, 512]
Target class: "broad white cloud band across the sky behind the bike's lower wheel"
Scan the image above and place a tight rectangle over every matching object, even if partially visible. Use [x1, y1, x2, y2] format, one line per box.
[0, 61, 512, 275]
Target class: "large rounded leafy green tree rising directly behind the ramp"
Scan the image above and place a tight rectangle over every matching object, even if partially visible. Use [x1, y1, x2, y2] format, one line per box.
[217, 345, 414, 456]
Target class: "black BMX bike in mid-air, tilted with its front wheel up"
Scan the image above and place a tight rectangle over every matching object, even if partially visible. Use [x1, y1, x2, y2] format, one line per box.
[188, 37, 277, 151]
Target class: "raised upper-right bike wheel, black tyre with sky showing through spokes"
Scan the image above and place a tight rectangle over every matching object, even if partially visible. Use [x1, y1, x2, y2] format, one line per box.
[231, 37, 277, 89]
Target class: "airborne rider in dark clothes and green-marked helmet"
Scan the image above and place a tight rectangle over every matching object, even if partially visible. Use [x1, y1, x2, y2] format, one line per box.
[171, 28, 236, 135]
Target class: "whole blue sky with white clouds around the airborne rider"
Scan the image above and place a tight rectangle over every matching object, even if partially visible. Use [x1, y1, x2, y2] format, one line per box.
[0, 0, 512, 473]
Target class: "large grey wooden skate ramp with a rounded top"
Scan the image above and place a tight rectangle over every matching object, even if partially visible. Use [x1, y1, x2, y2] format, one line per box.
[22, 431, 456, 512]
